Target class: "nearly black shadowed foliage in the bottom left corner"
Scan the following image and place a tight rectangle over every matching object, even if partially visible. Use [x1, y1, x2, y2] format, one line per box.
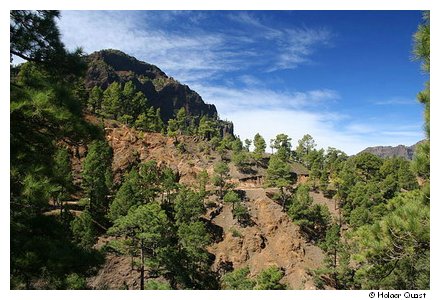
[10, 215, 103, 289]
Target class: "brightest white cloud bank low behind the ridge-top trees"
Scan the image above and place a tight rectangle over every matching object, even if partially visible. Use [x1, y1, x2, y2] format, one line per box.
[225, 109, 423, 155]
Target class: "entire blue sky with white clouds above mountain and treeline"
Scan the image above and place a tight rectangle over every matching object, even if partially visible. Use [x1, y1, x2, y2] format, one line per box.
[59, 11, 428, 154]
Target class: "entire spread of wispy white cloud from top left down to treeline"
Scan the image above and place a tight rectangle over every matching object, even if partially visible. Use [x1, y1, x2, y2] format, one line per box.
[59, 11, 423, 154]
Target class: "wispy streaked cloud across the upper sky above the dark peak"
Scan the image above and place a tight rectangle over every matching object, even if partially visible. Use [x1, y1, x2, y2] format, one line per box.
[59, 11, 331, 83]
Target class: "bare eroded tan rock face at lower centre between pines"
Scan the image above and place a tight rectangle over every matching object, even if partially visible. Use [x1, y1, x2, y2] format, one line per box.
[209, 188, 323, 289]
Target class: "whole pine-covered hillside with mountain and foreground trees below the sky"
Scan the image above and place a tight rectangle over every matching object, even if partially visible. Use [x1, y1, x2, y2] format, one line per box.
[10, 10, 431, 297]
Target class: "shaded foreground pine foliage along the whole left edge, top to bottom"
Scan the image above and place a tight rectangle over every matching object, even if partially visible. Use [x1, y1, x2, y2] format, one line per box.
[10, 11, 105, 289]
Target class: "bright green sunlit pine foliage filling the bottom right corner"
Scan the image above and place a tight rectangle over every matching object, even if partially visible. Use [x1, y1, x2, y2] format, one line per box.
[353, 190, 430, 289]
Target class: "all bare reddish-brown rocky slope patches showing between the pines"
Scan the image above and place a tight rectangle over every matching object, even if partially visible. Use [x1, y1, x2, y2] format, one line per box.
[74, 116, 331, 289]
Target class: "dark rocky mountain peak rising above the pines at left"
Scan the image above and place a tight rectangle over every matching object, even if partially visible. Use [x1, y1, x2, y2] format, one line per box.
[85, 50, 223, 123]
